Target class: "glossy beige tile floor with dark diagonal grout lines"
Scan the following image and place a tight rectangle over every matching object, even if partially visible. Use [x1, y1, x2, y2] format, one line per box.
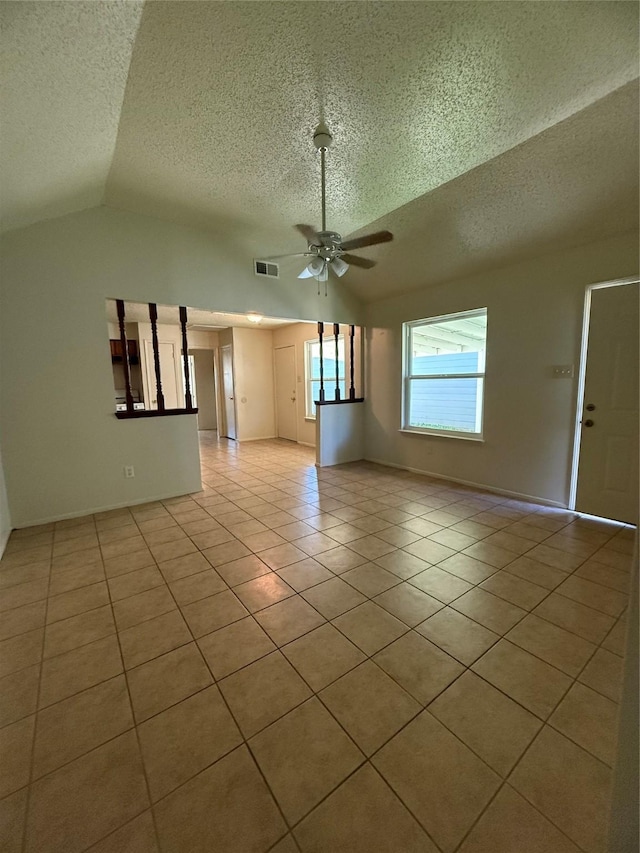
[0, 433, 635, 853]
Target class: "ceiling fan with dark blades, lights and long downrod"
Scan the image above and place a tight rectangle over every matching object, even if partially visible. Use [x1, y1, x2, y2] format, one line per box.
[268, 124, 393, 291]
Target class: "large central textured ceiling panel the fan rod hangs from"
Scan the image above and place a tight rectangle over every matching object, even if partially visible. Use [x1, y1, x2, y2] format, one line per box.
[106, 2, 638, 240]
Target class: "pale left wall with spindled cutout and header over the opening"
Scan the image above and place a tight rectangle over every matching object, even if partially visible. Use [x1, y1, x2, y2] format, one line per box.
[0, 207, 359, 526]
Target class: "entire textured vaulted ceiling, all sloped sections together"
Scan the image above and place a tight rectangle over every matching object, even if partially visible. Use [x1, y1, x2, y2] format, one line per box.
[0, 0, 638, 299]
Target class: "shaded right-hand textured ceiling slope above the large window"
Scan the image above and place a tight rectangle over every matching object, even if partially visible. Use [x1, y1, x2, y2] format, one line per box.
[300, 81, 639, 301]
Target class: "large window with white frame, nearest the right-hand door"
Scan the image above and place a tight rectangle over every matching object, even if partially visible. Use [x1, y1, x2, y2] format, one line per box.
[402, 308, 487, 438]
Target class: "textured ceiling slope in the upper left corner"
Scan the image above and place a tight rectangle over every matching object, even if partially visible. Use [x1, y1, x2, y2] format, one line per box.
[0, 0, 142, 229]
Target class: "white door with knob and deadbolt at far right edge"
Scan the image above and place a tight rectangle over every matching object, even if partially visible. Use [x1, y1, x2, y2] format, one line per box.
[576, 283, 640, 524]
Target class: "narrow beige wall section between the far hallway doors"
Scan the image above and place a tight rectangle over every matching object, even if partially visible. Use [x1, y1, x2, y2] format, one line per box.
[233, 329, 276, 441]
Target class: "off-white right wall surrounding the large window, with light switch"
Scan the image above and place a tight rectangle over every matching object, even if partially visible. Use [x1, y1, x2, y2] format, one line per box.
[365, 234, 638, 505]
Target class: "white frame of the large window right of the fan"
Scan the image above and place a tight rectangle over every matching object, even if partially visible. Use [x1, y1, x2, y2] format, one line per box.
[400, 308, 489, 441]
